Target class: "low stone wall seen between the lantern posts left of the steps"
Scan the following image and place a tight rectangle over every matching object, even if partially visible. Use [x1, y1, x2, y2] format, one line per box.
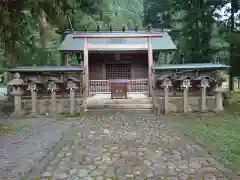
[22, 98, 83, 115]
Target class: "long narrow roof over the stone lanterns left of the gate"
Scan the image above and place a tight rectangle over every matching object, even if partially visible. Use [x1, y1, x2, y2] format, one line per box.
[8, 66, 83, 73]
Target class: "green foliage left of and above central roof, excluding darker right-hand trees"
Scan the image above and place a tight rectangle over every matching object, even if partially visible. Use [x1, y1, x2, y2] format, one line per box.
[0, 0, 143, 66]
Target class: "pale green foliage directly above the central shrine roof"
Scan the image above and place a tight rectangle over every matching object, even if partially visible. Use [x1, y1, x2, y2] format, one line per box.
[74, 0, 143, 30]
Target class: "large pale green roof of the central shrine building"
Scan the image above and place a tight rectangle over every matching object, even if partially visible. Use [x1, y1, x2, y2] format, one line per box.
[59, 31, 177, 51]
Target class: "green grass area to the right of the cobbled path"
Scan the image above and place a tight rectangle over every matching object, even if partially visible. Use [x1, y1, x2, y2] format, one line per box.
[171, 113, 240, 174]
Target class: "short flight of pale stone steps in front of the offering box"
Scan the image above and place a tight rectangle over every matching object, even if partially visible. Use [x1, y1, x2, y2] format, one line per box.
[87, 98, 153, 113]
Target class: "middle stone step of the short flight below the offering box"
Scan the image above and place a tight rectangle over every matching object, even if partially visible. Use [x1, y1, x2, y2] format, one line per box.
[87, 103, 153, 110]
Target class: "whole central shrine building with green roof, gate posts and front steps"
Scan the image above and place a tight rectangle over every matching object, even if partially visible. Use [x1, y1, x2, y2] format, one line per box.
[59, 29, 176, 110]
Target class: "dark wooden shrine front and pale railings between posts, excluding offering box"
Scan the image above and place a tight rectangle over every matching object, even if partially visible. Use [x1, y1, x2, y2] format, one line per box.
[89, 51, 149, 98]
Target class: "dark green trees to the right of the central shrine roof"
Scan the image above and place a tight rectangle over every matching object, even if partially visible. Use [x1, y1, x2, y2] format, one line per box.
[145, 0, 236, 63]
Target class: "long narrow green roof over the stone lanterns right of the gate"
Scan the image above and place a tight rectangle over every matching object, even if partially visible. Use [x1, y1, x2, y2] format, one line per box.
[153, 63, 230, 70]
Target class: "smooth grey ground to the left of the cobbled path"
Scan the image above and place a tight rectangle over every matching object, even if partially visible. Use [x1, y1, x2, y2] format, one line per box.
[0, 118, 79, 179]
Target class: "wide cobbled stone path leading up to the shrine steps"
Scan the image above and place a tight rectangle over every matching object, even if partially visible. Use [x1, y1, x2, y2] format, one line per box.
[41, 114, 232, 180]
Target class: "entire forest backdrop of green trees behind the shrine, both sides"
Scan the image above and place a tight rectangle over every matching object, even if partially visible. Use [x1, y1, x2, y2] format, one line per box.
[0, 0, 240, 73]
